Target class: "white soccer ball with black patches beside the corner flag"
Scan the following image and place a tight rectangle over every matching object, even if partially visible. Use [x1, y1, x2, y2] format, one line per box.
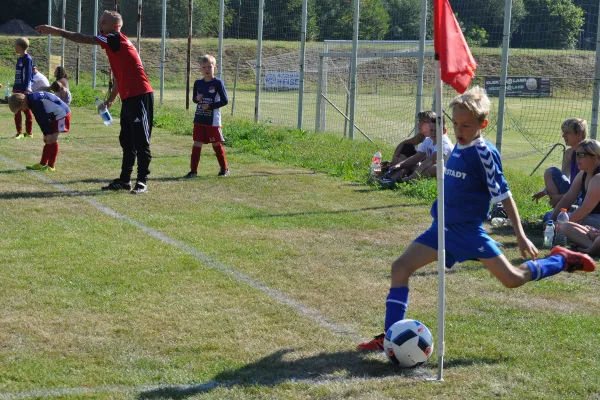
[383, 319, 433, 368]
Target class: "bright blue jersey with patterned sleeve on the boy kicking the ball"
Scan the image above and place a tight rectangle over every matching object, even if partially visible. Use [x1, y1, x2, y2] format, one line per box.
[431, 138, 512, 225]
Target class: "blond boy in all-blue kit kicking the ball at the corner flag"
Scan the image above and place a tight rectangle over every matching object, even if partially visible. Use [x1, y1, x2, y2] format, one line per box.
[357, 87, 596, 351]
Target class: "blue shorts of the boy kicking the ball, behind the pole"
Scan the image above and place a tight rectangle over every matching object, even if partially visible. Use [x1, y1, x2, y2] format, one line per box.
[415, 221, 502, 268]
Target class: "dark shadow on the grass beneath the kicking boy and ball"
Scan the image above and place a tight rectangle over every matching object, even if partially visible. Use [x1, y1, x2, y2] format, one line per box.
[138, 349, 502, 400]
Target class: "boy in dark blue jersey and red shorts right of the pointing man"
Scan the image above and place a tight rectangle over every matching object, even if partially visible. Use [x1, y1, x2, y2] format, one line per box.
[185, 54, 229, 178]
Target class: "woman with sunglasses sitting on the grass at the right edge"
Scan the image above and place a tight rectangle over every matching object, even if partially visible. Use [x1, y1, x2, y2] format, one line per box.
[550, 139, 600, 248]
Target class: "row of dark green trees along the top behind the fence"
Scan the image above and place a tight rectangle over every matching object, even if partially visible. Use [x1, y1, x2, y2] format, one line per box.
[0, 0, 598, 49]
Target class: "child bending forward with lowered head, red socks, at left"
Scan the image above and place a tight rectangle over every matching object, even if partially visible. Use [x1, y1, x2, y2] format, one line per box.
[8, 92, 71, 171]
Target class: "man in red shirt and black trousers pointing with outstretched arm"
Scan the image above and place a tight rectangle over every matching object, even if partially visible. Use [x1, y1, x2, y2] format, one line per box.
[35, 11, 154, 193]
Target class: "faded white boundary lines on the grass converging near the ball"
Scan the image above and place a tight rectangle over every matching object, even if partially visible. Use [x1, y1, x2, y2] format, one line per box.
[0, 154, 420, 400]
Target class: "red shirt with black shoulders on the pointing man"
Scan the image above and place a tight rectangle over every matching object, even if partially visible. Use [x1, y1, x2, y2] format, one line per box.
[94, 32, 152, 100]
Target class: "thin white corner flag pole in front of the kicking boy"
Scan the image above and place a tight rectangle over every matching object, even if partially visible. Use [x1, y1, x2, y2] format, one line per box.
[435, 53, 446, 381]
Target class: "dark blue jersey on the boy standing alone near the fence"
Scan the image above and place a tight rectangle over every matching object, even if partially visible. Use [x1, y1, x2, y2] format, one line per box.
[192, 78, 229, 126]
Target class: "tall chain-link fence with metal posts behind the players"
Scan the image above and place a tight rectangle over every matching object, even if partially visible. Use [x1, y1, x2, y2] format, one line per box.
[36, 0, 598, 170]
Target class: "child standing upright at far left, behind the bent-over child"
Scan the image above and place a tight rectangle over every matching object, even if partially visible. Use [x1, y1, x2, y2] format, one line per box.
[13, 38, 33, 139]
